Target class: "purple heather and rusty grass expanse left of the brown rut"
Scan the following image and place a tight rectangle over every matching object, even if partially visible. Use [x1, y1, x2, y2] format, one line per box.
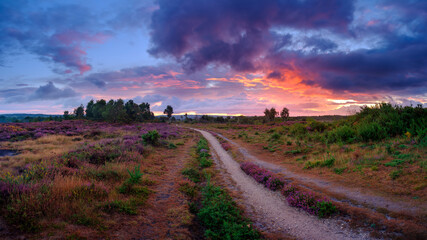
[0, 120, 186, 233]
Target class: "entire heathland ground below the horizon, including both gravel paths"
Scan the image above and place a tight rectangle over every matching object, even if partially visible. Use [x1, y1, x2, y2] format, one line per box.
[0, 105, 427, 239]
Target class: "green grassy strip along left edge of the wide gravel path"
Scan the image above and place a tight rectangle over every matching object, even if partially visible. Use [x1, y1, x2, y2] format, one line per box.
[180, 138, 261, 239]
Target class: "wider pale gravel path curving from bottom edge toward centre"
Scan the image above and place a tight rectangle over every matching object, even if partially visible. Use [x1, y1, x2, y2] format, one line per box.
[194, 129, 370, 239]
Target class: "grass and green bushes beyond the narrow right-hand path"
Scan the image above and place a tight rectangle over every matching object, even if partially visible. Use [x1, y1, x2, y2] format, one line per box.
[201, 103, 427, 200]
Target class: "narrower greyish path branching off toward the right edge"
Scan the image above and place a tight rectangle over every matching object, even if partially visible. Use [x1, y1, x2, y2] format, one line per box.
[218, 134, 427, 215]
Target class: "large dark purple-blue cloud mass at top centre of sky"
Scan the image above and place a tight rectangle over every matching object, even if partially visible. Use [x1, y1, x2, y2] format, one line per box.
[150, 0, 353, 71]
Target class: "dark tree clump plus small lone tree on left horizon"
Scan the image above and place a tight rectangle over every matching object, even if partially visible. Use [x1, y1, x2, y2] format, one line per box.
[64, 99, 173, 123]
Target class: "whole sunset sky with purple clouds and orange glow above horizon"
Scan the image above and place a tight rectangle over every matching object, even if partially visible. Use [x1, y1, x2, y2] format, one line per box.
[0, 0, 427, 116]
